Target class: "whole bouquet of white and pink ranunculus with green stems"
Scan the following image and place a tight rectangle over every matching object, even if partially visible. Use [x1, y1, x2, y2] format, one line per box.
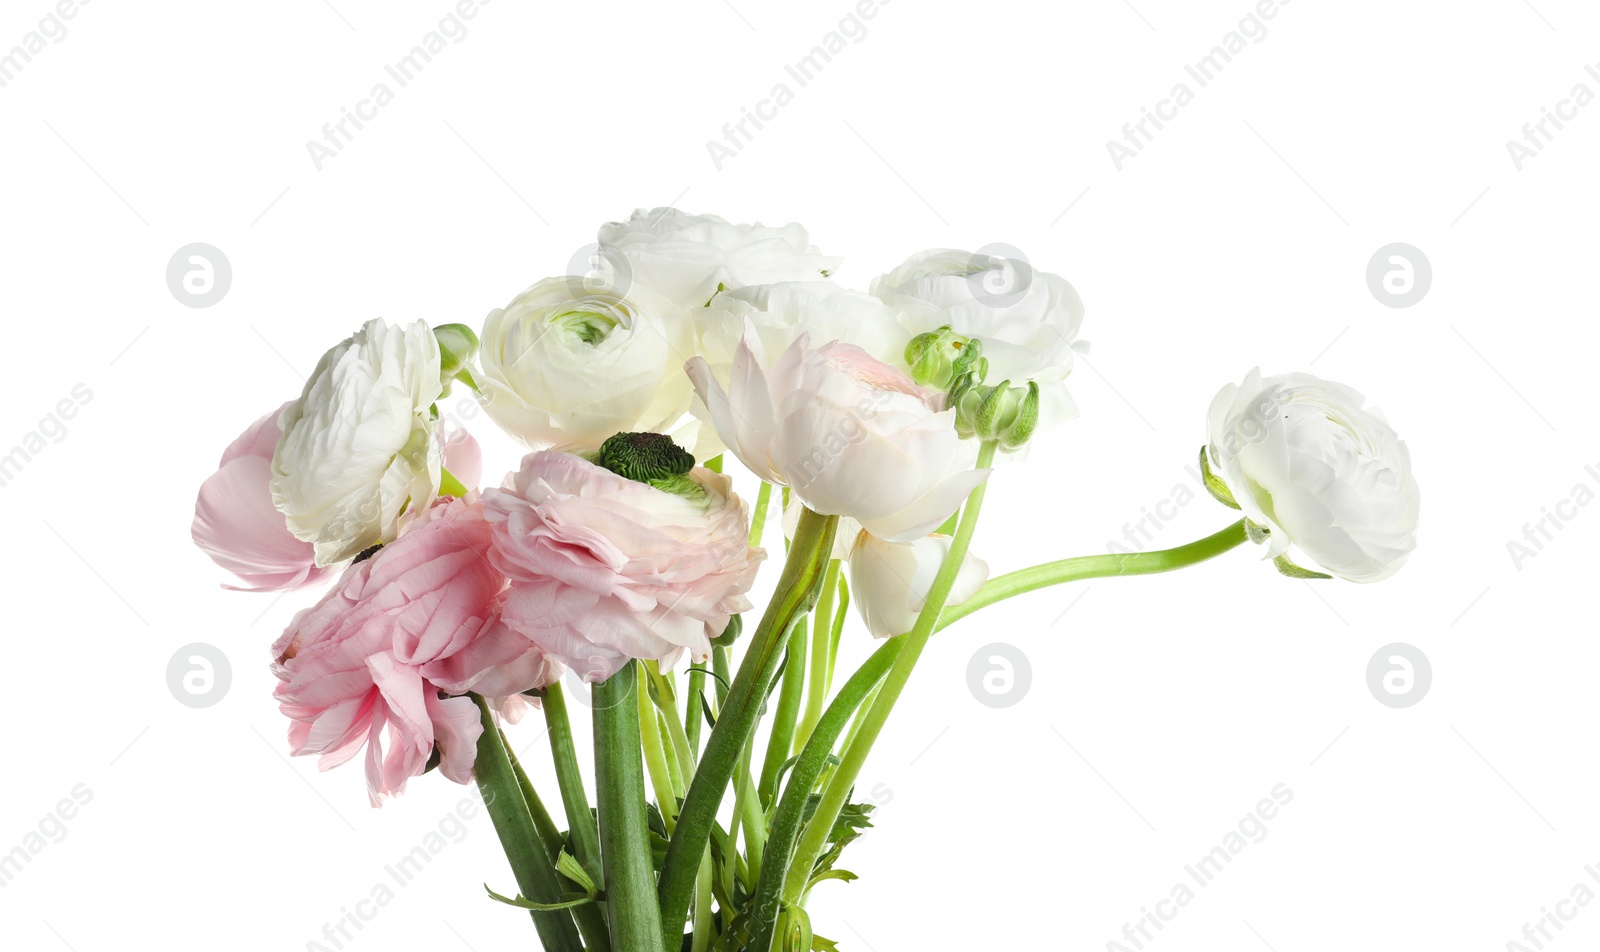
[194, 208, 1418, 952]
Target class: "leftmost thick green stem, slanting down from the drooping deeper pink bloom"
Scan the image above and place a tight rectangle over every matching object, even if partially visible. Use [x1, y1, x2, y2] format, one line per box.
[472, 694, 585, 952]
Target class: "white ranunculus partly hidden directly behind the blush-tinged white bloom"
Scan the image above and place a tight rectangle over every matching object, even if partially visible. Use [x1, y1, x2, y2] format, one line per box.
[696, 280, 910, 371]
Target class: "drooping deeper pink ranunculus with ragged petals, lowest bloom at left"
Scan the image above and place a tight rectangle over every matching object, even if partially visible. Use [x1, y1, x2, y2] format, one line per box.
[272, 494, 560, 805]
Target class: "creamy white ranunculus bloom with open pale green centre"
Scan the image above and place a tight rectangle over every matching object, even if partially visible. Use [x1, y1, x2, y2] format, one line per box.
[478, 277, 693, 446]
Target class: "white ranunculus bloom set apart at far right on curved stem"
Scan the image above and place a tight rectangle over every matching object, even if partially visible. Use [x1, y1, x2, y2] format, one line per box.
[1206, 370, 1419, 582]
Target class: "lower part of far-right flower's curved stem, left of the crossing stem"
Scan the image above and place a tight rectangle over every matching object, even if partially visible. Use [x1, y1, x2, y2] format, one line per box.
[749, 638, 904, 952]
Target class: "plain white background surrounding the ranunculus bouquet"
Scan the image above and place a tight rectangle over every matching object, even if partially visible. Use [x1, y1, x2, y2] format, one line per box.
[0, 0, 1600, 952]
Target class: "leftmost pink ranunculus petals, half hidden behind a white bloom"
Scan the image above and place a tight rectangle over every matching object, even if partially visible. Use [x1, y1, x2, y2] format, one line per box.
[189, 403, 331, 592]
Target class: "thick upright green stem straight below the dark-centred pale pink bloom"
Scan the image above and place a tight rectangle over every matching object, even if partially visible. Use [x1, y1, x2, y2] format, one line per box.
[594, 661, 668, 952]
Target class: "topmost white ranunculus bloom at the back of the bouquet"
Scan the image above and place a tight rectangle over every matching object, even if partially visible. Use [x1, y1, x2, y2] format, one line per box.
[598, 208, 840, 307]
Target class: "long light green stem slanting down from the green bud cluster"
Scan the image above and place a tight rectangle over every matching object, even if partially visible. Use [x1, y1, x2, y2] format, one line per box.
[784, 440, 995, 904]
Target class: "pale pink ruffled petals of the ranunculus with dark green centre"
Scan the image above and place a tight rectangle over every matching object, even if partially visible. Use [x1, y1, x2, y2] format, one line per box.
[483, 450, 766, 682]
